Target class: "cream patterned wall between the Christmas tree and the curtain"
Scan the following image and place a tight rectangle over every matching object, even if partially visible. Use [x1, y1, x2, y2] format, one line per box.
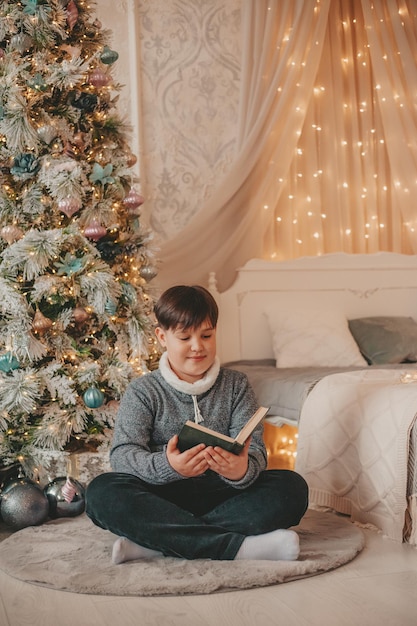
[99, 0, 242, 240]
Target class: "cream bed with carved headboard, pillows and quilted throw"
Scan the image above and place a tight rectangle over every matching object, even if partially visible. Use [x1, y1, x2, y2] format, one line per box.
[209, 252, 417, 545]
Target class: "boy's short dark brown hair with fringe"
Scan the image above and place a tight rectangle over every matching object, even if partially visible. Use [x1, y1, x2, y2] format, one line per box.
[154, 285, 219, 330]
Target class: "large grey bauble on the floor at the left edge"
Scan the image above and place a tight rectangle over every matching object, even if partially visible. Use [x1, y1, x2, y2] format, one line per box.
[0, 482, 49, 530]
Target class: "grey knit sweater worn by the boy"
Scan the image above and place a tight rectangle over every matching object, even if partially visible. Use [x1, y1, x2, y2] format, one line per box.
[110, 367, 266, 489]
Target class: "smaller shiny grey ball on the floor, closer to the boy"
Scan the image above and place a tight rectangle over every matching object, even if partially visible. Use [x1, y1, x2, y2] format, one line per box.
[44, 476, 85, 518]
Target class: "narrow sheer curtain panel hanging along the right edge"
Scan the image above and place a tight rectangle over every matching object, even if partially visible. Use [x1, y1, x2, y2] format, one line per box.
[362, 0, 417, 244]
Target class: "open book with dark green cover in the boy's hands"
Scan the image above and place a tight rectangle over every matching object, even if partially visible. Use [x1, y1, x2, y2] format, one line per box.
[178, 406, 269, 454]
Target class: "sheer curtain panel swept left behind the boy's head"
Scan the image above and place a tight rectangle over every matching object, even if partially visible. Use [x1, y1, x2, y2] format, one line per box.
[154, 0, 330, 289]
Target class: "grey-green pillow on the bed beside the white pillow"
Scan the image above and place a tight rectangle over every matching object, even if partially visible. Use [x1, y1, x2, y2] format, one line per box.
[349, 316, 417, 365]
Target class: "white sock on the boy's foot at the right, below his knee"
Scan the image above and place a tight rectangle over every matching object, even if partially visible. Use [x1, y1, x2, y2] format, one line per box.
[235, 529, 300, 561]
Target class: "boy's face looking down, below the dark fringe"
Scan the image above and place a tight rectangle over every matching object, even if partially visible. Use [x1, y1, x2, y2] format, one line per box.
[155, 321, 216, 383]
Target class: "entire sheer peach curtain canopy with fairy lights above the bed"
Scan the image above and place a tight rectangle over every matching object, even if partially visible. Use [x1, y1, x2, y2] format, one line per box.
[154, 0, 417, 290]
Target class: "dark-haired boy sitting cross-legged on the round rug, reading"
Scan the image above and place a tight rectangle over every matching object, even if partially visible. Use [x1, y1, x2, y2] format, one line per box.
[86, 285, 308, 563]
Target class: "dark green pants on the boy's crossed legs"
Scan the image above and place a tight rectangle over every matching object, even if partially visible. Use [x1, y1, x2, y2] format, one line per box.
[86, 470, 308, 560]
